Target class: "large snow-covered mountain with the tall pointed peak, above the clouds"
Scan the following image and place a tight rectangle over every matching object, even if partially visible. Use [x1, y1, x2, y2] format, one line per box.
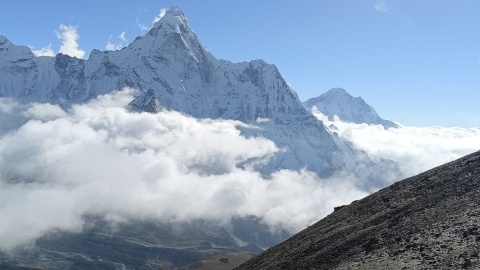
[0, 8, 345, 176]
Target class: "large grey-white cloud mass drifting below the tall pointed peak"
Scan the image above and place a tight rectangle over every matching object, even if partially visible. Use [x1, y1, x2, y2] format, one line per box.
[0, 89, 367, 251]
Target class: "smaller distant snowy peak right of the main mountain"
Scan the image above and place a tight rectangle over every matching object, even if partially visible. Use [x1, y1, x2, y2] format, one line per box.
[303, 88, 398, 129]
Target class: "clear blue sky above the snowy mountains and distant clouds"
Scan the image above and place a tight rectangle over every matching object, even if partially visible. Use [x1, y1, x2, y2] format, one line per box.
[0, 0, 480, 127]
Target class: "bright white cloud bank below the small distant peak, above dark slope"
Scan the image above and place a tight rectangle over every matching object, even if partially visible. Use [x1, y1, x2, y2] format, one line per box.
[312, 108, 480, 177]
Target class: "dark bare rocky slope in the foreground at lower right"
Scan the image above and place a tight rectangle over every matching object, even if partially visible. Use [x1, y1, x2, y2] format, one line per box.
[237, 152, 480, 269]
